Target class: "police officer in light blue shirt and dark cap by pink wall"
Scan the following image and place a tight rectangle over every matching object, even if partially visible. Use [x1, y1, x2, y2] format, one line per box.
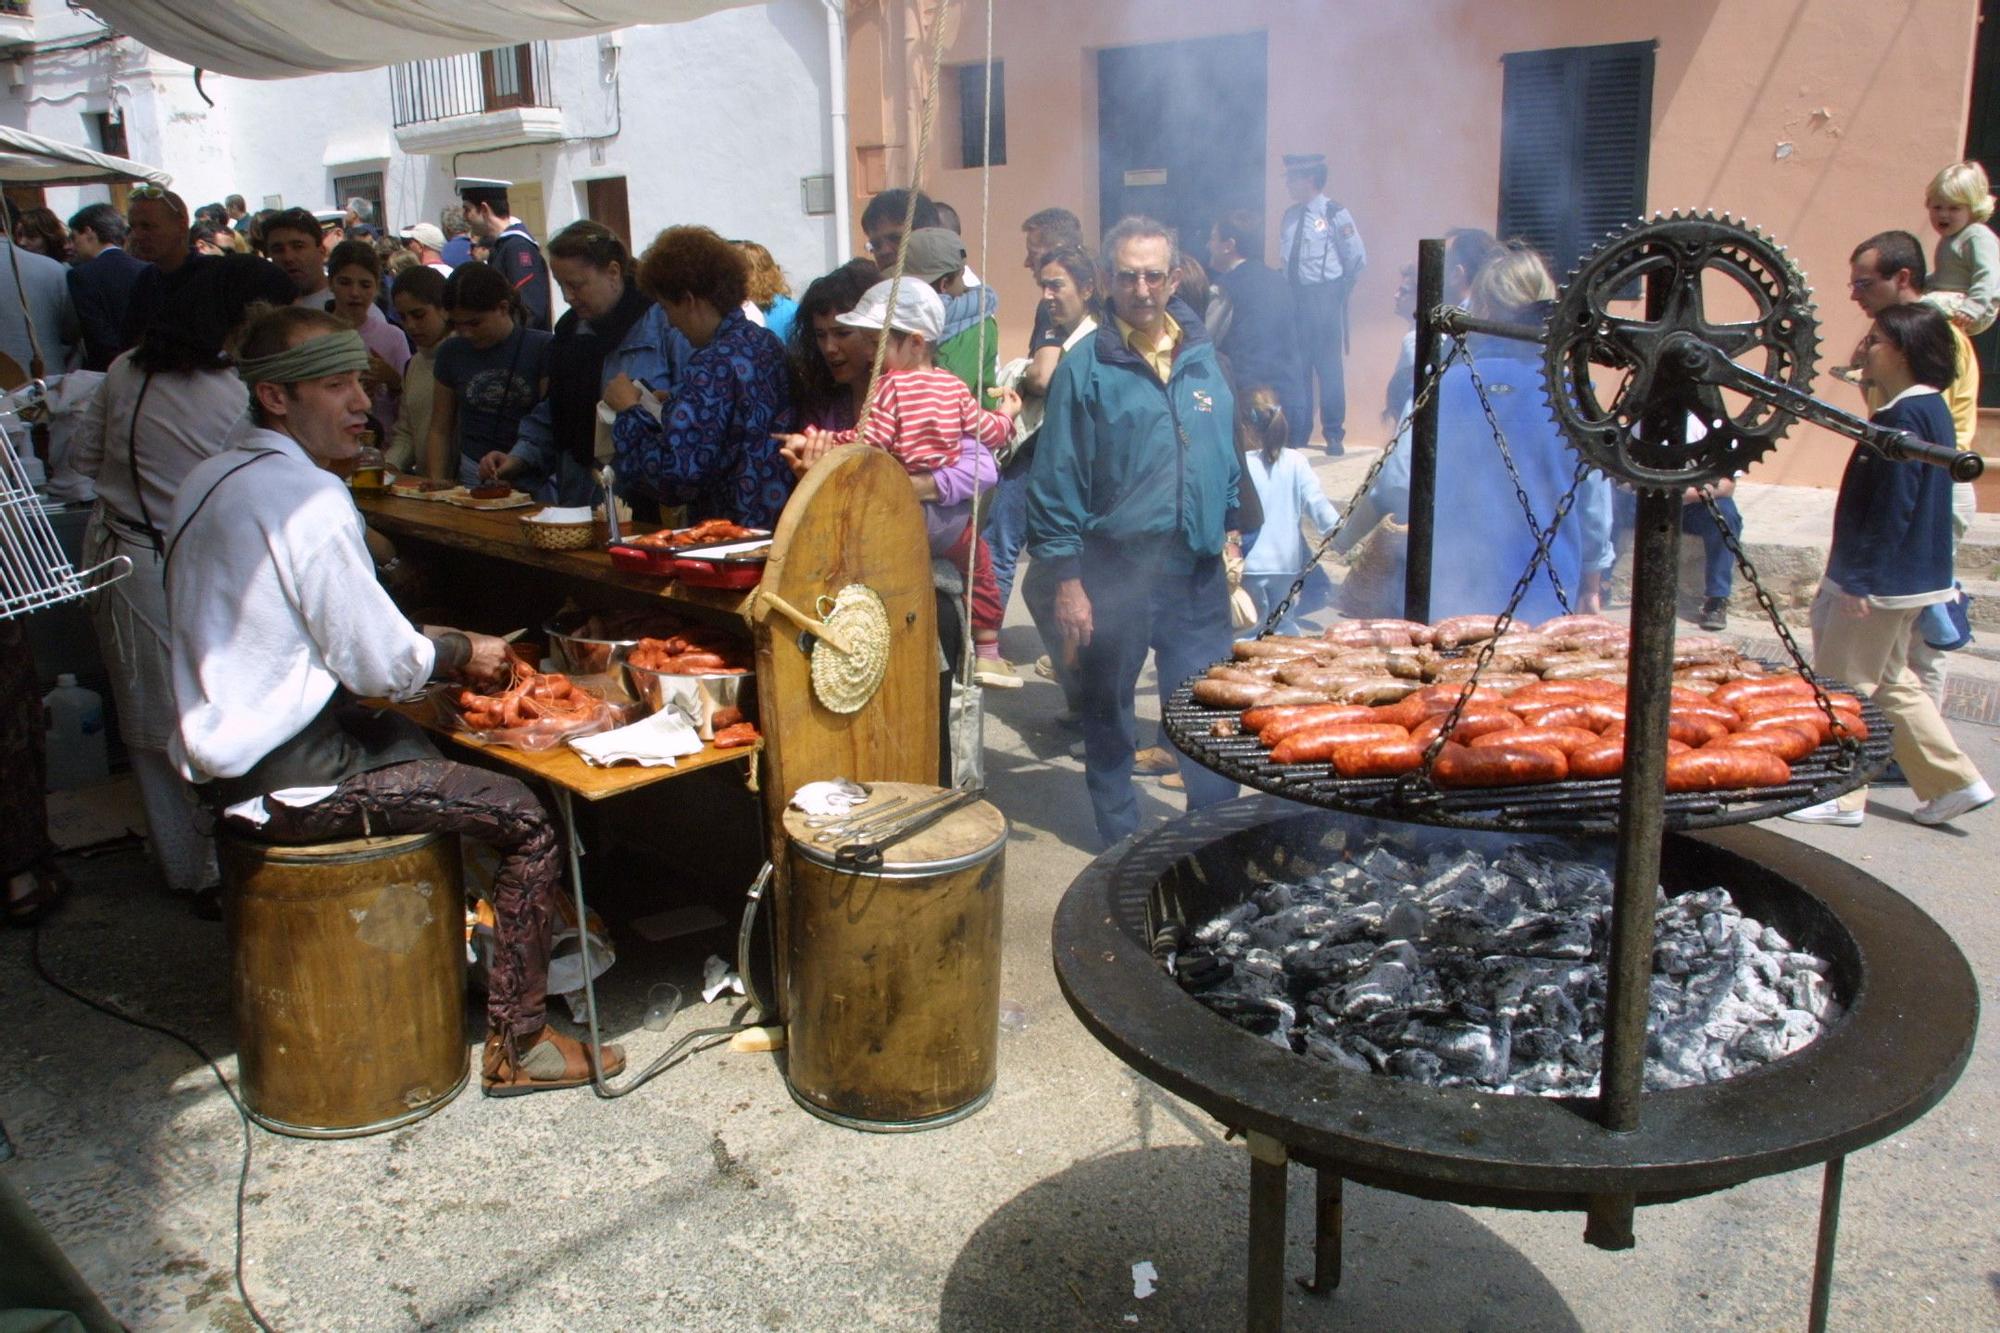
[1278, 152, 1368, 454]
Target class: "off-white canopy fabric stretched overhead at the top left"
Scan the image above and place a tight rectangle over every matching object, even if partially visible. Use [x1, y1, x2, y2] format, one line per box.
[88, 0, 754, 78]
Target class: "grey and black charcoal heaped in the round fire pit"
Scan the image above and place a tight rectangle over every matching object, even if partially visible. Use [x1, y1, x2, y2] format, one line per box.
[1176, 843, 1840, 1097]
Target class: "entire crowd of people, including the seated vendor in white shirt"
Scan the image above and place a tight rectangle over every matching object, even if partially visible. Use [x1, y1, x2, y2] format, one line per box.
[0, 156, 2000, 1093]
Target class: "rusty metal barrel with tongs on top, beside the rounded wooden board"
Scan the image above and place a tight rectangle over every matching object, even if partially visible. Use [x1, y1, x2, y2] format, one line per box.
[784, 783, 1008, 1133]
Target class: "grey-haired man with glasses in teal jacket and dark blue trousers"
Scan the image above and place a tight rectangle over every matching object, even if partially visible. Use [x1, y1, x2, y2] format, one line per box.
[1028, 218, 1242, 847]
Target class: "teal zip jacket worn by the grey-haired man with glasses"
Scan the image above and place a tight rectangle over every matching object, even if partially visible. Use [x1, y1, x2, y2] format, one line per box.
[1028, 300, 1242, 578]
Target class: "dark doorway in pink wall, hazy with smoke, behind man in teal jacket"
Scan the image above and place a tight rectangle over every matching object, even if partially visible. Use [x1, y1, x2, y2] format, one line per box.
[1098, 32, 1272, 264]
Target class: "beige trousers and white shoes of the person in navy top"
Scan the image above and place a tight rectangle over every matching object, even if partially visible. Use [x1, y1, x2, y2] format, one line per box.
[1812, 580, 1980, 811]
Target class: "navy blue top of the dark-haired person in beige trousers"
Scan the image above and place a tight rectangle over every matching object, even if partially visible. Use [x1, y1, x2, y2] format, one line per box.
[1826, 392, 1958, 596]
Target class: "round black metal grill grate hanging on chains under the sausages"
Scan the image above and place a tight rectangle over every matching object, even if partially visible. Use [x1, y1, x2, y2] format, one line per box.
[1166, 664, 1890, 833]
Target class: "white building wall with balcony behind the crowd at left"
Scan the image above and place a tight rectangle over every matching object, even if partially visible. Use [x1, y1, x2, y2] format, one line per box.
[0, 0, 848, 288]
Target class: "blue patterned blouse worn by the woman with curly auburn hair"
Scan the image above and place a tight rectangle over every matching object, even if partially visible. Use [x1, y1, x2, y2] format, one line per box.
[612, 310, 794, 528]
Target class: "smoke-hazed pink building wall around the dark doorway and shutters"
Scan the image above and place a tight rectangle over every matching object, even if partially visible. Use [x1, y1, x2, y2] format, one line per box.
[850, 0, 2000, 486]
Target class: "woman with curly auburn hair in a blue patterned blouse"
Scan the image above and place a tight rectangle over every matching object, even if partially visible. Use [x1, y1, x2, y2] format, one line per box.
[604, 226, 792, 528]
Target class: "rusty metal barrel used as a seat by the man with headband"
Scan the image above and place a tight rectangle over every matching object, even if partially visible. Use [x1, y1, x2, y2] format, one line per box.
[220, 833, 470, 1139]
